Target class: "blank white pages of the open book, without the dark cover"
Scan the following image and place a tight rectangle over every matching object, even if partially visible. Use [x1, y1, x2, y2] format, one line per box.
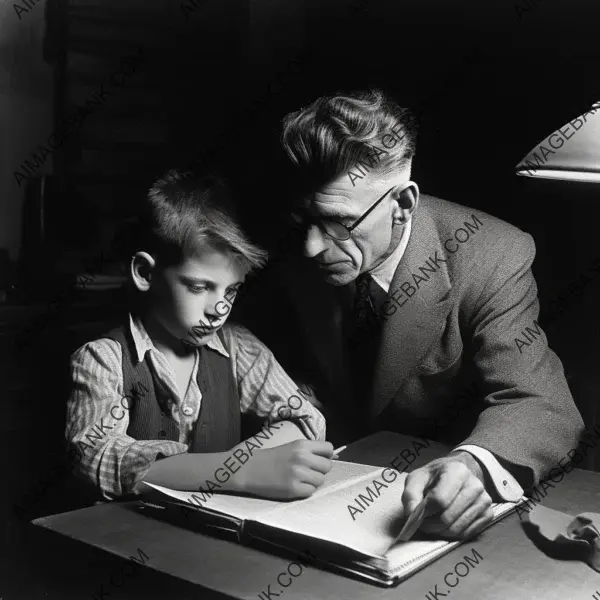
[146, 468, 515, 574]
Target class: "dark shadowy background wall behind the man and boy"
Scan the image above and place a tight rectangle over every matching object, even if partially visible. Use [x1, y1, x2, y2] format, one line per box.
[0, 0, 600, 598]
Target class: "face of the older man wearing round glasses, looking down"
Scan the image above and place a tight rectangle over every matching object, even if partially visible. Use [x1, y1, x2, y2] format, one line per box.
[304, 174, 408, 285]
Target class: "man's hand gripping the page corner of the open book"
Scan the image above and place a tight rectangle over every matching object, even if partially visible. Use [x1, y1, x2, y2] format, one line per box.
[402, 452, 493, 539]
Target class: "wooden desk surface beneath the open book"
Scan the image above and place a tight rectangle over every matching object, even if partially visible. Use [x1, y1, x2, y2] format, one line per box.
[34, 432, 600, 600]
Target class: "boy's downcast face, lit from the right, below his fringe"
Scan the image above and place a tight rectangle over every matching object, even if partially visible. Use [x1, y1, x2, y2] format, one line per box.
[141, 245, 247, 346]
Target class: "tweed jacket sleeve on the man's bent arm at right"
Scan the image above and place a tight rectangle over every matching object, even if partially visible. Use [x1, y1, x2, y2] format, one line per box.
[462, 232, 583, 489]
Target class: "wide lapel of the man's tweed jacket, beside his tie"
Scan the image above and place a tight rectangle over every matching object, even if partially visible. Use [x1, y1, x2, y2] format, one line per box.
[369, 201, 452, 420]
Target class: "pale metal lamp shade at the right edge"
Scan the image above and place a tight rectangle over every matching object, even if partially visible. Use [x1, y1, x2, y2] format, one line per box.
[517, 102, 600, 183]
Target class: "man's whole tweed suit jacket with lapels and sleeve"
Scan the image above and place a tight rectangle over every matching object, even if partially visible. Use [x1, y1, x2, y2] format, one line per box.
[286, 194, 583, 488]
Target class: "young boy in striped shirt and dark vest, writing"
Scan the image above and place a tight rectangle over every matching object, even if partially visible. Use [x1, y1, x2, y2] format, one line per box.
[66, 171, 333, 499]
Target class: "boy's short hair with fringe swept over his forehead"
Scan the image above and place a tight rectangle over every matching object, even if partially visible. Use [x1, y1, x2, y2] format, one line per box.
[138, 169, 267, 270]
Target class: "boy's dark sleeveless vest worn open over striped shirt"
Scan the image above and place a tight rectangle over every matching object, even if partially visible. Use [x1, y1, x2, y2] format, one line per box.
[102, 325, 240, 452]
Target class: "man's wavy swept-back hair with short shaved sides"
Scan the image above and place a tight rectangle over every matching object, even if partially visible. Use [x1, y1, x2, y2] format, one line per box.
[281, 90, 417, 187]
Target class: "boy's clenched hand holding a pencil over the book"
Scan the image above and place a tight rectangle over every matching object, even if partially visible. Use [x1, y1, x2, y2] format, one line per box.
[240, 440, 333, 500]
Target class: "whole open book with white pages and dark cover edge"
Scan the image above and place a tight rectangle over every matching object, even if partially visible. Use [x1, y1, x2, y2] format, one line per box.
[146, 460, 515, 585]
